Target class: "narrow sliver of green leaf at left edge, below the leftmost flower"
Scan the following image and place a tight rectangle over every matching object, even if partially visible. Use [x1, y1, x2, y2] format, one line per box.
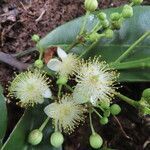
[0, 85, 7, 148]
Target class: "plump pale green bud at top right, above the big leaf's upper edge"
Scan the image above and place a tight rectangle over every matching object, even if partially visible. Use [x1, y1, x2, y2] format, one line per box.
[122, 5, 133, 18]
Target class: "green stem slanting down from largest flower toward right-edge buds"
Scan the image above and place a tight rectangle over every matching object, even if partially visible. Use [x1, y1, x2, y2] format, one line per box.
[116, 93, 139, 108]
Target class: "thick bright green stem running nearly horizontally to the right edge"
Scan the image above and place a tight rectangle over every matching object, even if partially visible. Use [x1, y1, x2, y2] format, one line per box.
[110, 57, 150, 70]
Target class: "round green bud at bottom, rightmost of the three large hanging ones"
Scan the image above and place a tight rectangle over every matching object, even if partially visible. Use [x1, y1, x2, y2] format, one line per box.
[89, 133, 103, 149]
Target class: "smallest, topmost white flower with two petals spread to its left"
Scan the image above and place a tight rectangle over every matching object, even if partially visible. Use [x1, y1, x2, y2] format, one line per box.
[47, 47, 78, 76]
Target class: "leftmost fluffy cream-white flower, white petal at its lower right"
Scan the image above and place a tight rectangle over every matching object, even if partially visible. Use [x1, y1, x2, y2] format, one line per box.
[8, 70, 52, 107]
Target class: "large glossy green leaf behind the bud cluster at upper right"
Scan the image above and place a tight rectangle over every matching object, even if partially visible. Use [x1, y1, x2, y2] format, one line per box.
[40, 6, 150, 82]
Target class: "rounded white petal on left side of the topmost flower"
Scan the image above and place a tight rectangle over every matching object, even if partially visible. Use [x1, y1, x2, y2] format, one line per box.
[47, 58, 61, 71]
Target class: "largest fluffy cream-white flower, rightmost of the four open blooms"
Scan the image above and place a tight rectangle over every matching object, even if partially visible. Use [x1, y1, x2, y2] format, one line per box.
[73, 58, 118, 105]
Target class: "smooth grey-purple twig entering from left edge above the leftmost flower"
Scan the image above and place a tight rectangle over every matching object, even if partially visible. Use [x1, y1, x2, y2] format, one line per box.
[0, 52, 29, 70]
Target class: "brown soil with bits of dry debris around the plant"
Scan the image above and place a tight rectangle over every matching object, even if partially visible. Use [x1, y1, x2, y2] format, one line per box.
[0, 0, 150, 150]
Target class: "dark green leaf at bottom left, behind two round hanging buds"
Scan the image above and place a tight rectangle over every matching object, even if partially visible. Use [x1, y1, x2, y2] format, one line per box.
[2, 101, 62, 150]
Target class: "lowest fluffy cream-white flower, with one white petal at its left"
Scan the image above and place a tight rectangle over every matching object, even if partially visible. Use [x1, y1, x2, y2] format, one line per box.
[44, 95, 86, 133]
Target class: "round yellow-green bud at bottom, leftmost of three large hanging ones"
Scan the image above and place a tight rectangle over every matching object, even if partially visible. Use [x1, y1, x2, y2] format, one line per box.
[28, 129, 43, 145]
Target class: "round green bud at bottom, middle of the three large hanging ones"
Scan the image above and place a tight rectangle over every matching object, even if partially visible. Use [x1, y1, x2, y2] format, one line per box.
[50, 131, 64, 148]
